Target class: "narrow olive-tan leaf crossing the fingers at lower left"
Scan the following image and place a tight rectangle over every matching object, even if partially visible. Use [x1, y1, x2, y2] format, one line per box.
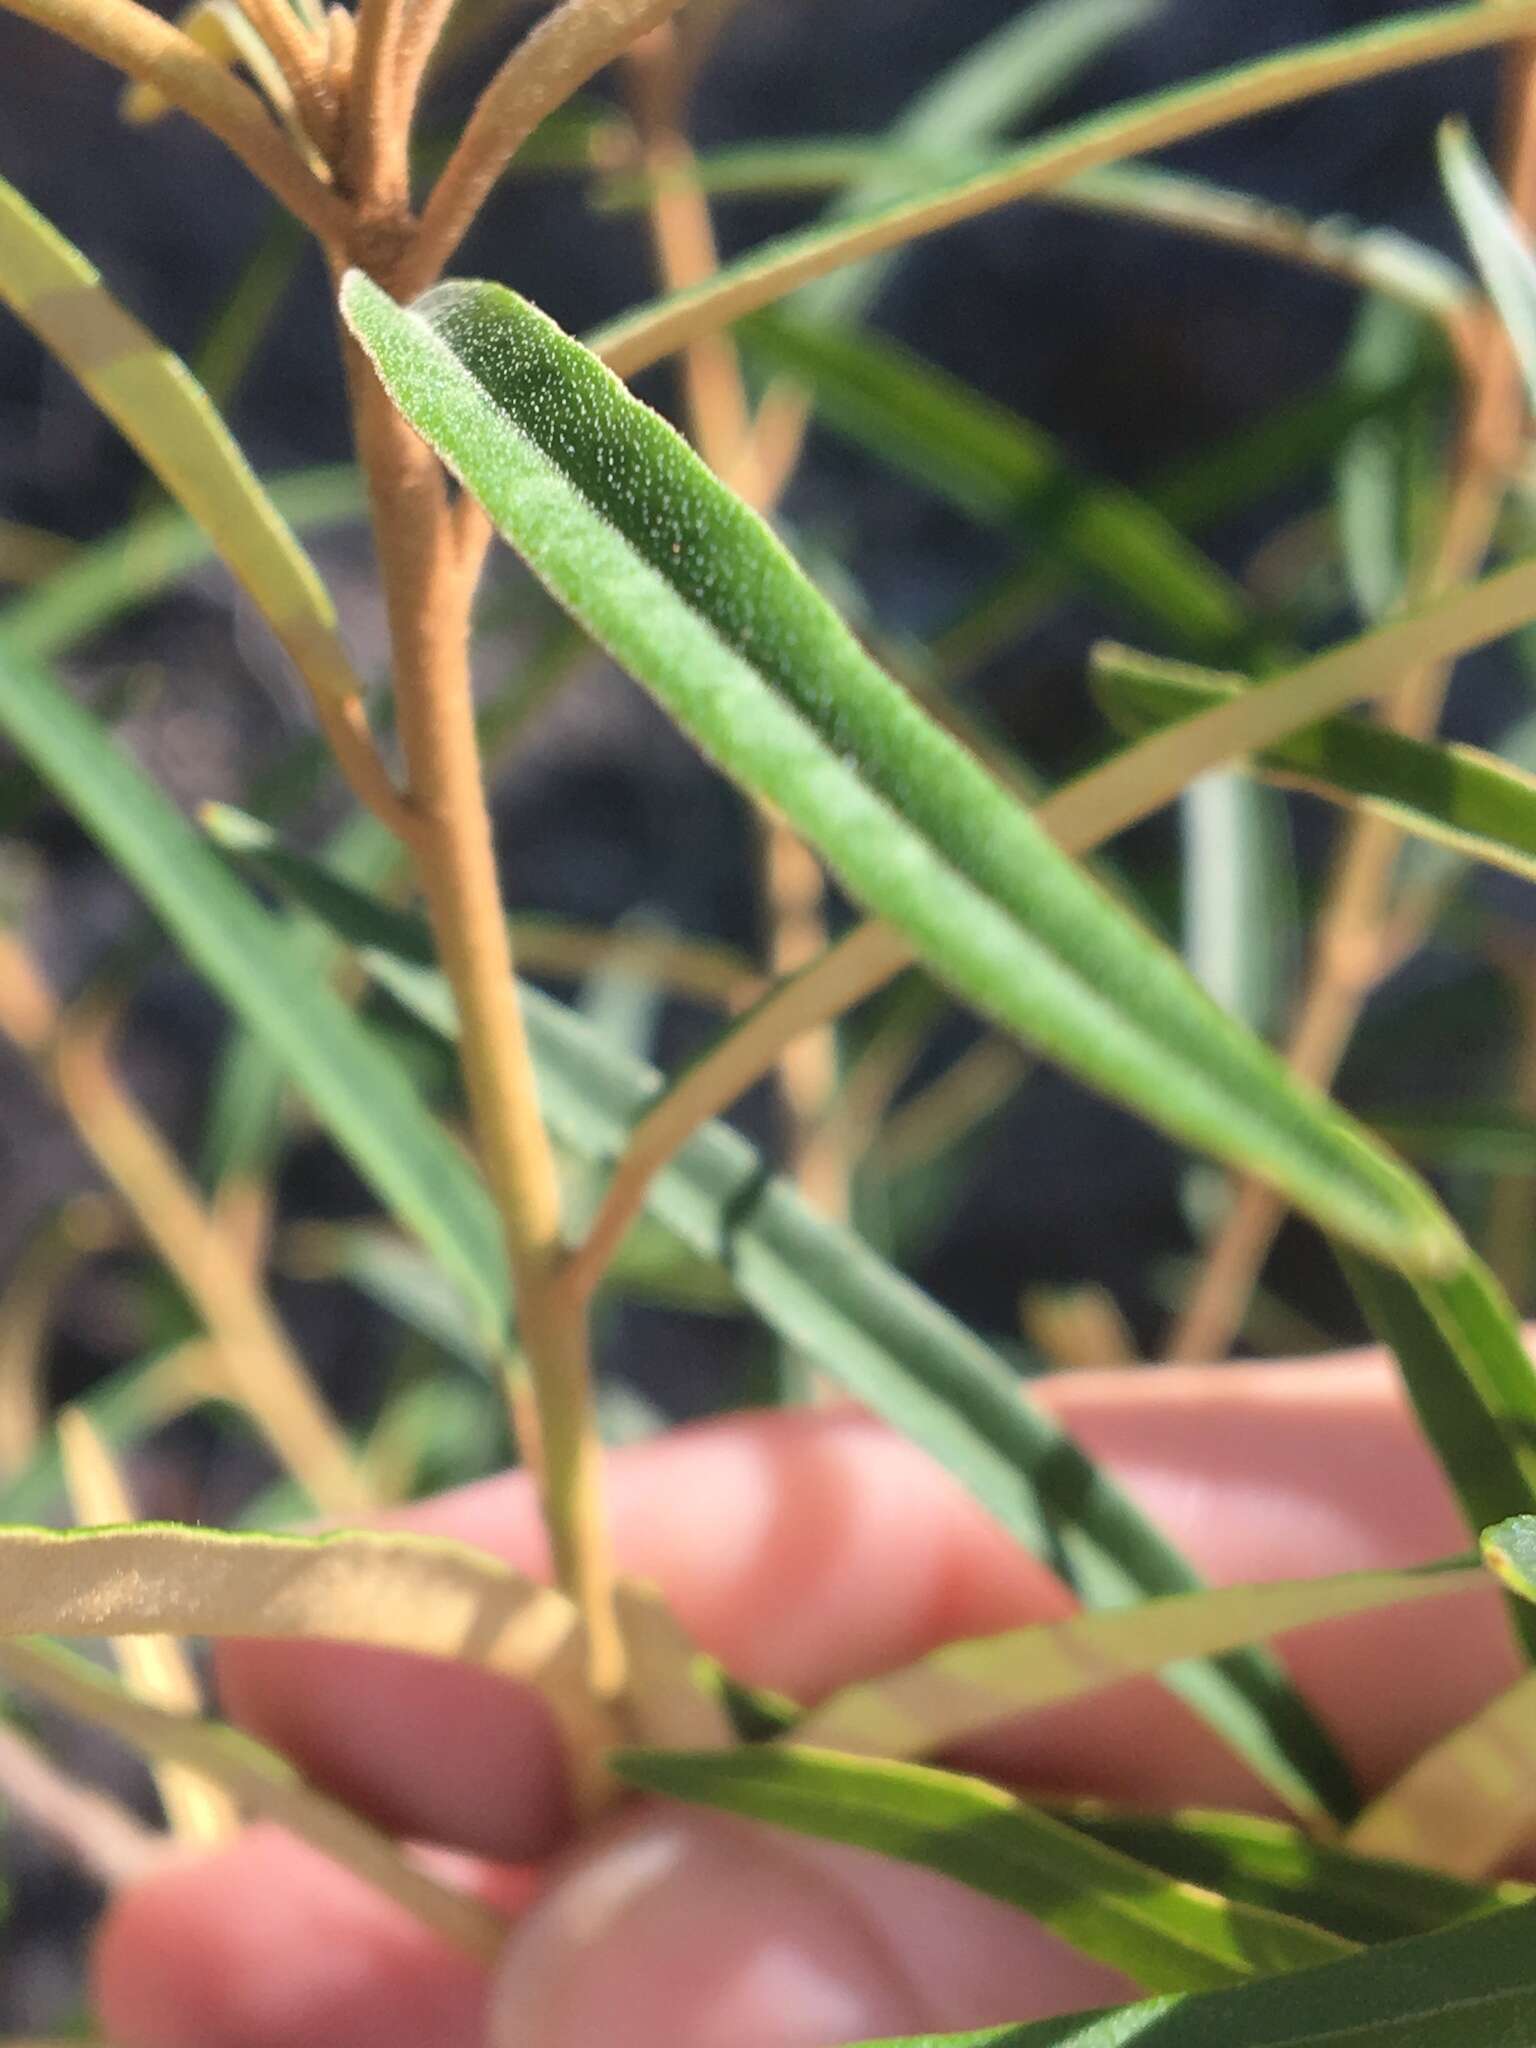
[0, 1642, 506, 1964]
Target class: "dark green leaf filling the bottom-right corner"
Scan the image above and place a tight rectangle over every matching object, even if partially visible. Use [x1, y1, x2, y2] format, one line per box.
[860, 1905, 1536, 2048]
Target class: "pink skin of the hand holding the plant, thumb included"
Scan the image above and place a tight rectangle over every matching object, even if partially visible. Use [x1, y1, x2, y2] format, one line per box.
[94, 1354, 1516, 2048]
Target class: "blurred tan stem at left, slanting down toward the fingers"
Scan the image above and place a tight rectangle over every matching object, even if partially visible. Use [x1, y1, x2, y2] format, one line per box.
[0, 932, 369, 1513]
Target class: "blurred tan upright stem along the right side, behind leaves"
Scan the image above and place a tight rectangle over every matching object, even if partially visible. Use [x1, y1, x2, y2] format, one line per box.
[1167, 28, 1536, 1360]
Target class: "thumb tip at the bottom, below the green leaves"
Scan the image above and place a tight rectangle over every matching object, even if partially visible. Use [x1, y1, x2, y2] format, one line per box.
[489, 1808, 1130, 2048]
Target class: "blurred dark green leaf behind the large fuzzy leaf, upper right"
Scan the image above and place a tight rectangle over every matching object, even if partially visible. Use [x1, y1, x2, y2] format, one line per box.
[741, 313, 1262, 664]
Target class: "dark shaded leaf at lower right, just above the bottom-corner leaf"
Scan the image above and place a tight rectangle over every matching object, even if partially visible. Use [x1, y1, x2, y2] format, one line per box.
[1059, 1806, 1534, 1942]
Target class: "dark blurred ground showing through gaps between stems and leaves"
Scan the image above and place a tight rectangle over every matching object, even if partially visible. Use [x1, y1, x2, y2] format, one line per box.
[0, 0, 1518, 2028]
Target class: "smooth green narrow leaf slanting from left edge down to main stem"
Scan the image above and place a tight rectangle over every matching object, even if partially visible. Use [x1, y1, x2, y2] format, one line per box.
[0, 639, 506, 1329]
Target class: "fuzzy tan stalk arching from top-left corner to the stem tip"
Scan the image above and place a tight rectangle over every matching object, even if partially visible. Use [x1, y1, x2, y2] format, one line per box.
[0, 0, 346, 242]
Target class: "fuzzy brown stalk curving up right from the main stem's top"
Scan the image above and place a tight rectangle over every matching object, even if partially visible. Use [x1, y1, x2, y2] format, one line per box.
[403, 0, 682, 299]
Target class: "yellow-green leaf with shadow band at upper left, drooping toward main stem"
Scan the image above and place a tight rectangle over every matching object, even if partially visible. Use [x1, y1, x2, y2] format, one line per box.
[0, 180, 370, 720]
